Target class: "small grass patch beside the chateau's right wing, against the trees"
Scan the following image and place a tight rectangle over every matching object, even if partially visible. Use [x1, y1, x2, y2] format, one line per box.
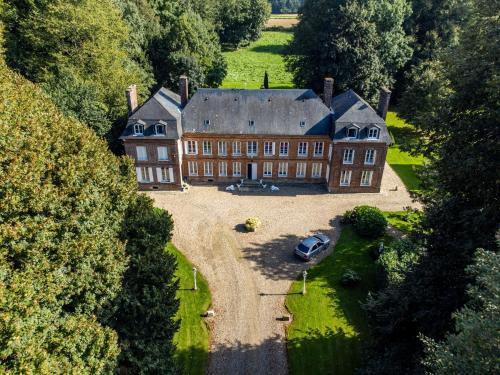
[386, 112, 424, 191]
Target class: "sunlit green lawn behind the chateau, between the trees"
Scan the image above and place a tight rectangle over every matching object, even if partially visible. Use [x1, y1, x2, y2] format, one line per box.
[221, 31, 293, 89]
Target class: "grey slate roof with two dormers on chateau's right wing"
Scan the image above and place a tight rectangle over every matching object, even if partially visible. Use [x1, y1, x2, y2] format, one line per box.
[331, 90, 391, 144]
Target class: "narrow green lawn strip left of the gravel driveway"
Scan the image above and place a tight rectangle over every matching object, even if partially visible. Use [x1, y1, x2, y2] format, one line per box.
[167, 243, 211, 375]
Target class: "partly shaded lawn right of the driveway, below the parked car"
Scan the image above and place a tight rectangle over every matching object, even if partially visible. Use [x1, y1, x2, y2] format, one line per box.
[286, 226, 392, 375]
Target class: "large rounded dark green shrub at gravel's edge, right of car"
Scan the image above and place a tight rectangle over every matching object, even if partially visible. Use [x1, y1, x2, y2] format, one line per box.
[343, 206, 387, 238]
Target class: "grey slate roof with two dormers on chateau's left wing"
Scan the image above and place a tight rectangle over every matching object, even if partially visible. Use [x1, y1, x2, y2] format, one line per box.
[120, 87, 182, 139]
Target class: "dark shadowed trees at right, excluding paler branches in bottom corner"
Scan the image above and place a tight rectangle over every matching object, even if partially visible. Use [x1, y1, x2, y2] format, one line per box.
[365, 0, 500, 374]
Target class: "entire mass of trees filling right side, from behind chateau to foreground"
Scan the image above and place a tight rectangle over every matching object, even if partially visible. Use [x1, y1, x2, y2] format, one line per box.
[287, 0, 500, 375]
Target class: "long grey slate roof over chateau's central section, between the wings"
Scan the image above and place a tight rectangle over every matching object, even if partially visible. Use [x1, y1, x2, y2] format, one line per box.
[182, 89, 331, 135]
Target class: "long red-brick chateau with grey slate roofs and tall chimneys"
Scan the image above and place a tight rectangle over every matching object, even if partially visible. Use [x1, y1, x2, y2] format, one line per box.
[121, 76, 391, 193]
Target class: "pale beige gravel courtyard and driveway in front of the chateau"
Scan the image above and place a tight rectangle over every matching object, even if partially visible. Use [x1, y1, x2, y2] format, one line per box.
[149, 165, 415, 375]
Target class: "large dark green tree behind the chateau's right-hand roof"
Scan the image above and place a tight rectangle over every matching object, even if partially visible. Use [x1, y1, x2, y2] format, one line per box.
[286, 0, 411, 101]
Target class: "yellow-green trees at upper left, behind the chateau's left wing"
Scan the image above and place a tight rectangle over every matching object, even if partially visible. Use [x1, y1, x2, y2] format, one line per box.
[0, 0, 270, 145]
